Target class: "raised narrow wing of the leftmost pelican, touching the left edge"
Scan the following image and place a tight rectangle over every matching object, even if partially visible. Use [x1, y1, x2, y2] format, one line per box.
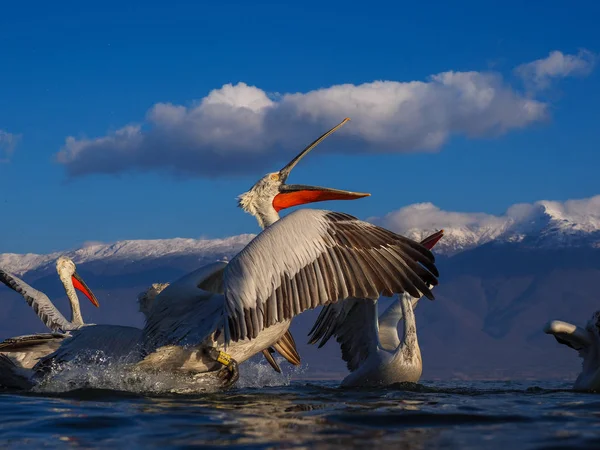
[0, 269, 78, 331]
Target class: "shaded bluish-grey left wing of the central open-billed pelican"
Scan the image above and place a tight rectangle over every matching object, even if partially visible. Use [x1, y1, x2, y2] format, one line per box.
[143, 262, 227, 352]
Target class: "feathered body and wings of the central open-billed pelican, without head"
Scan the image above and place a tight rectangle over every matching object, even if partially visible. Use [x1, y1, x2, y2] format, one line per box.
[140, 210, 437, 386]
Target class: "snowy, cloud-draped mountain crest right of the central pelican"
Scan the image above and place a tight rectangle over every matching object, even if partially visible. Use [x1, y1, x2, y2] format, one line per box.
[368, 195, 600, 253]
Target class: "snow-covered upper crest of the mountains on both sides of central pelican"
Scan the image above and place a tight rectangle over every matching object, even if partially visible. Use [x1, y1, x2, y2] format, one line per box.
[0, 196, 600, 275]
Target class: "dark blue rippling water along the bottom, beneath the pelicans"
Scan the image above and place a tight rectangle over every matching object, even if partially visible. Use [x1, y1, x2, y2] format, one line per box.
[0, 381, 600, 450]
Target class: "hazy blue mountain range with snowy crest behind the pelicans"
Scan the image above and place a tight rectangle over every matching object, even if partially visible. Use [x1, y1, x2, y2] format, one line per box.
[0, 196, 600, 379]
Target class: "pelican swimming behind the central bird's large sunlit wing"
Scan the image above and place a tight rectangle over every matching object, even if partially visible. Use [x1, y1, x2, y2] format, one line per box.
[309, 230, 444, 387]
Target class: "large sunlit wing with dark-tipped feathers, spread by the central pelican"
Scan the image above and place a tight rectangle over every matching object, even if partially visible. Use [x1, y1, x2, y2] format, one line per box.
[223, 209, 438, 341]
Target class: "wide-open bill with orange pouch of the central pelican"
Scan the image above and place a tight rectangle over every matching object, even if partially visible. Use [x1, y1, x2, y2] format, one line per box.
[273, 118, 371, 211]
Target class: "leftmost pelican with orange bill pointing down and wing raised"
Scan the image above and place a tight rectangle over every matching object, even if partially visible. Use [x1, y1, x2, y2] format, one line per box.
[0, 256, 100, 368]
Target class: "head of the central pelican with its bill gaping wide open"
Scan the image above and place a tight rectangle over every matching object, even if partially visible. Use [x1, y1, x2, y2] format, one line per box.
[238, 118, 371, 228]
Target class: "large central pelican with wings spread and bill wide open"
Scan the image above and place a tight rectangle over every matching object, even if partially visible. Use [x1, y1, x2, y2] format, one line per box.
[143, 119, 438, 384]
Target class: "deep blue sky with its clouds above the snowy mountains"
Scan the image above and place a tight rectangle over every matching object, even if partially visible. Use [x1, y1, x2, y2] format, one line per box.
[0, 1, 600, 253]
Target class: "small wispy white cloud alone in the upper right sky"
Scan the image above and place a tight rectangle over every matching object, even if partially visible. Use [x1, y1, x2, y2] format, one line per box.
[515, 50, 596, 89]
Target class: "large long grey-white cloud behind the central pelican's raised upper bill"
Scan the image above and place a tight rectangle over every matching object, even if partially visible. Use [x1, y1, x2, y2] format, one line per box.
[57, 58, 547, 177]
